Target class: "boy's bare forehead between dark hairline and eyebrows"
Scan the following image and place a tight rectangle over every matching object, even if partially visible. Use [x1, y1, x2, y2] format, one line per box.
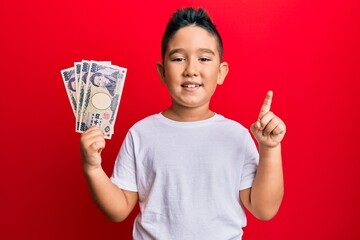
[167, 25, 219, 54]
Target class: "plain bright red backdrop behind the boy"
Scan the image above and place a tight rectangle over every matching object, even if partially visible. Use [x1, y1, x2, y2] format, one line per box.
[0, 0, 360, 240]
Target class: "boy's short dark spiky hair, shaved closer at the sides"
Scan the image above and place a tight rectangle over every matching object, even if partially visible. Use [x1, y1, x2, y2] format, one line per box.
[161, 7, 223, 61]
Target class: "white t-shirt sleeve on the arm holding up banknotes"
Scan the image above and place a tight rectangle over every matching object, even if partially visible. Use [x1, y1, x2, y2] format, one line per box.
[110, 131, 137, 192]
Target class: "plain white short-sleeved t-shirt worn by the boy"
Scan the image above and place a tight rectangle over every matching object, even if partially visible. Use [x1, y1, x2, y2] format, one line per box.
[111, 113, 259, 240]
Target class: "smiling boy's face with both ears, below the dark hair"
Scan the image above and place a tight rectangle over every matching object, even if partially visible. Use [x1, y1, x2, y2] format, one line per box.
[157, 25, 228, 110]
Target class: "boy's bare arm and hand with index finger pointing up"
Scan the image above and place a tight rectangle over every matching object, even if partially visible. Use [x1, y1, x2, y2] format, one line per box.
[240, 91, 286, 220]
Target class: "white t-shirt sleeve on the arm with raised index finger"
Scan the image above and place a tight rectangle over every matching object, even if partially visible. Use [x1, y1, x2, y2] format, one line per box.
[239, 132, 259, 190]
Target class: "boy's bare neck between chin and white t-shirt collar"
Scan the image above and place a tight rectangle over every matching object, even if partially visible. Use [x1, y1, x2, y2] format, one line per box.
[162, 104, 215, 122]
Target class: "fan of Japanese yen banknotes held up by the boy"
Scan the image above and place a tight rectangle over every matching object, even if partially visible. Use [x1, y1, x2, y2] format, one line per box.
[61, 60, 127, 139]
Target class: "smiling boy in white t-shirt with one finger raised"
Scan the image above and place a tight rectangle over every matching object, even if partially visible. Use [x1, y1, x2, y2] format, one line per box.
[81, 8, 285, 240]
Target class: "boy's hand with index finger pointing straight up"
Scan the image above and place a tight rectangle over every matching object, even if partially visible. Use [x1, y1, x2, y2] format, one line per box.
[250, 91, 286, 148]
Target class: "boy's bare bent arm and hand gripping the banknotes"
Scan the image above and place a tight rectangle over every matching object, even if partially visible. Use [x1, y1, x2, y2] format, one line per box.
[80, 127, 138, 222]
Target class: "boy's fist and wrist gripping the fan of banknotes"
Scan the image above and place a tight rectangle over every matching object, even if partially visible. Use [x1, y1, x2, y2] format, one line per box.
[80, 126, 105, 171]
